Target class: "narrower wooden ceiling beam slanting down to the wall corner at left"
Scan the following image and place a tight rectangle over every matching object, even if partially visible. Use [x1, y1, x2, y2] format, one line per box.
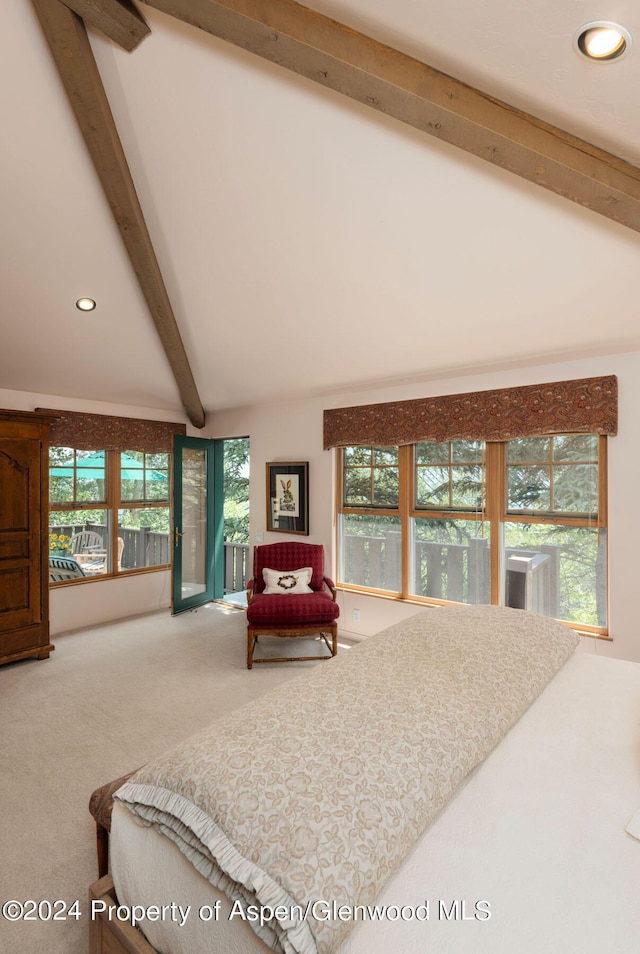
[32, 0, 205, 427]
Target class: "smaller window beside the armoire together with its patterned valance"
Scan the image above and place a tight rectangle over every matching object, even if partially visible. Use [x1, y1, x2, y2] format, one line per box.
[38, 410, 186, 585]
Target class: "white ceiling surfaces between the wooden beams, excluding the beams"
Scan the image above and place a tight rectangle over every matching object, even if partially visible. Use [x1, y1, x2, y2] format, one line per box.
[0, 0, 640, 420]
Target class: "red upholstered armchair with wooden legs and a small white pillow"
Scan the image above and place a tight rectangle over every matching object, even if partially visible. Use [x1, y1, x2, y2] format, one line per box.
[247, 542, 340, 669]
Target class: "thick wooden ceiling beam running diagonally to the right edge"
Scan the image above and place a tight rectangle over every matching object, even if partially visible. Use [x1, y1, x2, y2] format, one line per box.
[144, 0, 640, 231]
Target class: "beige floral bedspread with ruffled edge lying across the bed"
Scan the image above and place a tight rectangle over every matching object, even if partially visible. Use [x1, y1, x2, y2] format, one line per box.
[116, 606, 578, 954]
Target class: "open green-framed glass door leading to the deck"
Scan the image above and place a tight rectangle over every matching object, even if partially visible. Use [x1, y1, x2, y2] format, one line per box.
[172, 437, 224, 614]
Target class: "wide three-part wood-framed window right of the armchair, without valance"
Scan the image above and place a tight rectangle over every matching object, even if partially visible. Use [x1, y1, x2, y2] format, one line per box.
[338, 434, 607, 633]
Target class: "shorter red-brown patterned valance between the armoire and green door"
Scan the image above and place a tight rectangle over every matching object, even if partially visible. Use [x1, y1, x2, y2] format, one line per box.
[37, 408, 187, 454]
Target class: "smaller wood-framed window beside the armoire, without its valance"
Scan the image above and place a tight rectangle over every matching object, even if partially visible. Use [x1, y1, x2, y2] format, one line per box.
[49, 446, 171, 577]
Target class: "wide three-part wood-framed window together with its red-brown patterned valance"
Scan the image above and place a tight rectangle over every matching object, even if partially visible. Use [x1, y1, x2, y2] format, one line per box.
[324, 376, 617, 636]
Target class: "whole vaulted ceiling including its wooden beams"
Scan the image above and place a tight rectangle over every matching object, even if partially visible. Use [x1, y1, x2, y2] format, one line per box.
[0, 0, 640, 426]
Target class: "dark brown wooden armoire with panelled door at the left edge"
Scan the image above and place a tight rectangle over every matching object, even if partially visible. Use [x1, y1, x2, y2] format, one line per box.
[0, 410, 54, 664]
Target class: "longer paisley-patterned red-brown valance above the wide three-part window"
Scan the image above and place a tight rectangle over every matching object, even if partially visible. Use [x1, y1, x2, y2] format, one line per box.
[324, 374, 618, 450]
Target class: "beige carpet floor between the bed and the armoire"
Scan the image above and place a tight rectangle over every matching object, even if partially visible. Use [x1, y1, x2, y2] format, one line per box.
[0, 604, 344, 954]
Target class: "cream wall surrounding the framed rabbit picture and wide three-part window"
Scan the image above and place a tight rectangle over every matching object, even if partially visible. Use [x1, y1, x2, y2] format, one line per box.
[204, 353, 640, 661]
